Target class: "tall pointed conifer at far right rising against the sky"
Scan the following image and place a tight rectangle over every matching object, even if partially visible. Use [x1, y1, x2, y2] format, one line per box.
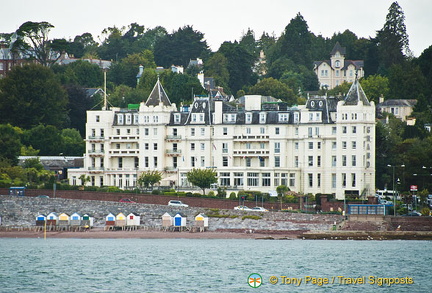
[376, 2, 410, 71]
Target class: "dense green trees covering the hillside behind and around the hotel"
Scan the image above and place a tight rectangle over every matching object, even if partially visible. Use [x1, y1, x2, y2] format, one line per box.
[0, 2, 432, 196]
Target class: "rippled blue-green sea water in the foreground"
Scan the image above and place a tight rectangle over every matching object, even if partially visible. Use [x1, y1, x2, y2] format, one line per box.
[0, 238, 432, 293]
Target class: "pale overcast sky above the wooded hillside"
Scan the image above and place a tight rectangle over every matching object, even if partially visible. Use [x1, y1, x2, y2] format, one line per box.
[0, 0, 432, 56]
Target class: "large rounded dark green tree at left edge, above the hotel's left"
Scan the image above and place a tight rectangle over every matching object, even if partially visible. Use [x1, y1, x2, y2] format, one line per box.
[0, 64, 68, 129]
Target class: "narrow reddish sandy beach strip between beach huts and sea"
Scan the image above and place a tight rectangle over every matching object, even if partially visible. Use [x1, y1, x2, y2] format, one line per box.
[0, 228, 298, 239]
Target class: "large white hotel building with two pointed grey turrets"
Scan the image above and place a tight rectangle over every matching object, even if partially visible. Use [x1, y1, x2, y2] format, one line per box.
[68, 80, 375, 199]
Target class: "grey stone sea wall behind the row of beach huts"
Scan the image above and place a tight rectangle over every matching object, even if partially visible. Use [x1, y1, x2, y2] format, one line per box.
[0, 195, 342, 231]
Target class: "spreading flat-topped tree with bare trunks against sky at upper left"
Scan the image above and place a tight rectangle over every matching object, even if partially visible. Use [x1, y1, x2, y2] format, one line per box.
[14, 21, 67, 66]
